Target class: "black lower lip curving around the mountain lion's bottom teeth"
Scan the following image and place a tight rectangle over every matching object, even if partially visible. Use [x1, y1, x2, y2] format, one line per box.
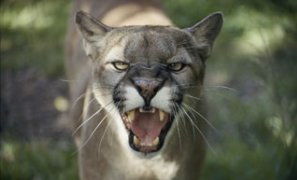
[128, 114, 174, 154]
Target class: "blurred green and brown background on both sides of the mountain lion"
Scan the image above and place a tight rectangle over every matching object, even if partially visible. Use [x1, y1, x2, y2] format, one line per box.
[0, 0, 297, 180]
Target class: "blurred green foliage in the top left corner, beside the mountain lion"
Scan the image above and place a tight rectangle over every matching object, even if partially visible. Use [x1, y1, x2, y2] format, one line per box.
[0, 0, 70, 76]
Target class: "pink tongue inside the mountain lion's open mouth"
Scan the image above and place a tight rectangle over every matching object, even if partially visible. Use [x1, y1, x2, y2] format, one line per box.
[131, 109, 167, 142]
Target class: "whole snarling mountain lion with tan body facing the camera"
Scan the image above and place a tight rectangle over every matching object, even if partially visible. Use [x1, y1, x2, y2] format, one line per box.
[65, 0, 223, 180]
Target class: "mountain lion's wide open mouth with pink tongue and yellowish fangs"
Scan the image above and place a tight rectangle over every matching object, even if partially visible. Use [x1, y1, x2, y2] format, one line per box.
[122, 108, 173, 153]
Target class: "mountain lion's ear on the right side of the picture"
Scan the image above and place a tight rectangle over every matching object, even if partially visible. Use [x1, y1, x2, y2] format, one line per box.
[185, 12, 223, 58]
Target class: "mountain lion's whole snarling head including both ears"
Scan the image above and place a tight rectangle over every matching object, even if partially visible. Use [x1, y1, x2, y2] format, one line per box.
[77, 13, 221, 154]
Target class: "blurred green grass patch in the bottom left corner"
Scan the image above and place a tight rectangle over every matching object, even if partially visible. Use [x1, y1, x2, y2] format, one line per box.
[0, 139, 78, 180]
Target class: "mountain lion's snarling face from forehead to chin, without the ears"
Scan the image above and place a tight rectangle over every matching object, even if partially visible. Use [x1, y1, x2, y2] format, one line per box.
[93, 27, 204, 153]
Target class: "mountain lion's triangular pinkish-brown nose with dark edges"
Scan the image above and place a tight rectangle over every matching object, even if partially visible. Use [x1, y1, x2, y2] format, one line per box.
[132, 78, 163, 105]
